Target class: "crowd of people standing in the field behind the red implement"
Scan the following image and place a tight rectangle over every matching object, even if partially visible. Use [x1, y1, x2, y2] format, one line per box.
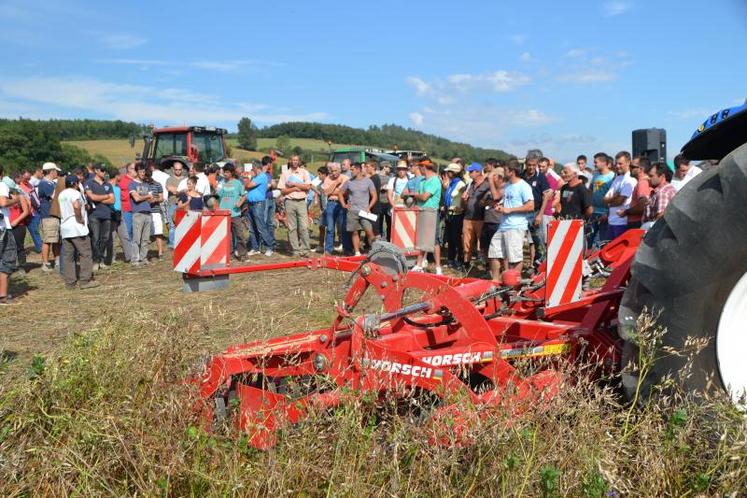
[0, 151, 701, 304]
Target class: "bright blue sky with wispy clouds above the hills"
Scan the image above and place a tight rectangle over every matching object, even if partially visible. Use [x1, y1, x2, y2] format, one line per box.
[0, 0, 747, 161]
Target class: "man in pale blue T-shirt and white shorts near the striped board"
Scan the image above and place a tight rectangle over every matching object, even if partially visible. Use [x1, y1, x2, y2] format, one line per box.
[488, 159, 534, 283]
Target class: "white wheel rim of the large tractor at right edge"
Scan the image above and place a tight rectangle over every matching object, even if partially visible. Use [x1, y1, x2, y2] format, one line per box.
[716, 273, 747, 409]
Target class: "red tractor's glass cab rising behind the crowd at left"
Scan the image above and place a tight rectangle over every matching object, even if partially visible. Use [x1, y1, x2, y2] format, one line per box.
[142, 126, 227, 169]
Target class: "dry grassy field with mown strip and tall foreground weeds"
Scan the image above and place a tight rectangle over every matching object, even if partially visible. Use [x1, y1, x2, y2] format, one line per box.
[0, 241, 747, 497]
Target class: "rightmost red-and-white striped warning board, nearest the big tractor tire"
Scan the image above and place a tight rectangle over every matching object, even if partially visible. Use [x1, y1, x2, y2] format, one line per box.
[545, 220, 584, 308]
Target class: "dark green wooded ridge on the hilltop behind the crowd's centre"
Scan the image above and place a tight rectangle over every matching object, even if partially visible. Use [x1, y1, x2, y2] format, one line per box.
[256, 122, 513, 161]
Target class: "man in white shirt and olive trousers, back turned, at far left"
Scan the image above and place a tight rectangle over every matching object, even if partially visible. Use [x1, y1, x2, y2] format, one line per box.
[57, 175, 99, 289]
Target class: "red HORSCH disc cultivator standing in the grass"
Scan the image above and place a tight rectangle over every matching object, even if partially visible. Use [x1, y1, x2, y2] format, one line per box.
[195, 222, 643, 448]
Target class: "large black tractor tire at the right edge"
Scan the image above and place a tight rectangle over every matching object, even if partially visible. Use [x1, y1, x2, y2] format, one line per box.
[619, 144, 747, 404]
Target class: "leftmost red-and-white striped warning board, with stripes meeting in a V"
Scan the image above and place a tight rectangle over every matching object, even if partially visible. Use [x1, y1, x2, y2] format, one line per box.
[174, 211, 231, 274]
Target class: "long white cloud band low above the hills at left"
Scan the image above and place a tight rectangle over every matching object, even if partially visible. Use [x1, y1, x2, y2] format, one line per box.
[0, 77, 329, 124]
